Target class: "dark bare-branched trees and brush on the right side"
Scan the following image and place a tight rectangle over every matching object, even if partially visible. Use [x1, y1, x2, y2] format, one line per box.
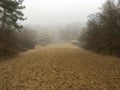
[79, 0, 120, 55]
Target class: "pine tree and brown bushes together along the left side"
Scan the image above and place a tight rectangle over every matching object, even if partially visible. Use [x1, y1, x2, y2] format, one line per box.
[0, 0, 36, 56]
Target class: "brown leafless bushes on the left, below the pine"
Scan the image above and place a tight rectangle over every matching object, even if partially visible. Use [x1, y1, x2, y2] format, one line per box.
[0, 28, 36, 56]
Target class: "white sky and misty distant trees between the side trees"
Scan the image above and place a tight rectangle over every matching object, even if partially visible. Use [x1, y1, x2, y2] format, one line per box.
[22, 0, 105, 43]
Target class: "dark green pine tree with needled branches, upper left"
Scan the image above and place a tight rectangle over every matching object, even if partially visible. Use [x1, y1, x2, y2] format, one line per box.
[0, 0, 25, 32]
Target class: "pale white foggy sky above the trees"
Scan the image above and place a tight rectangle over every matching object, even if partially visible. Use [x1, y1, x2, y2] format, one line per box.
[24, 0, 105, 26]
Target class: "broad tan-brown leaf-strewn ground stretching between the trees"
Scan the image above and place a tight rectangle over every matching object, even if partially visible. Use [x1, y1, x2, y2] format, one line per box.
[0, 44, 120, 90]
